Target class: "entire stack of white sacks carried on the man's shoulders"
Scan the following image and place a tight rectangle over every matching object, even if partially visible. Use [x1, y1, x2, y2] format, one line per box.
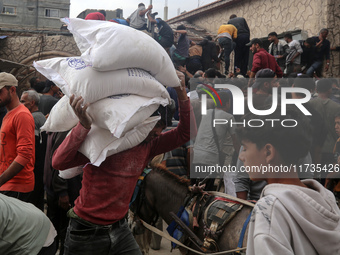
[34, 19, 180, 169]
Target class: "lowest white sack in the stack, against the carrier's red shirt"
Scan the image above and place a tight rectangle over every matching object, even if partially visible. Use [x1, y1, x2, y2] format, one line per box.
[78, 116, 160, 166]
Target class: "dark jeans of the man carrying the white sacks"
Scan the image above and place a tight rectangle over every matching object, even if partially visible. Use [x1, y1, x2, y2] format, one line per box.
[64, 218, 142, 255]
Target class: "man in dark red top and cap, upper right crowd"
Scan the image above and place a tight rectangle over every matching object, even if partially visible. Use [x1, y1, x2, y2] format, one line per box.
[247, 38, 283, 85]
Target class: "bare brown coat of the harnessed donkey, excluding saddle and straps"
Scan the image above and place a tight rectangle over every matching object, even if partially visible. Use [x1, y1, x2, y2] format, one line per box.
[131, 165, 252, 254]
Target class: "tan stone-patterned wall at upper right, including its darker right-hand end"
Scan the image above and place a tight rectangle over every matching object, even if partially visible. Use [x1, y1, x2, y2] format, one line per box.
[182, 0, 340, 77]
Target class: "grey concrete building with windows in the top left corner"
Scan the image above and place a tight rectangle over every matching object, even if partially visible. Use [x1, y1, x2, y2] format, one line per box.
[0, 0, 70, 30]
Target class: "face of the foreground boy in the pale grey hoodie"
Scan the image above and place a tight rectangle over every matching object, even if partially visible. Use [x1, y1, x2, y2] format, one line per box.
[239, 140, 268, 180]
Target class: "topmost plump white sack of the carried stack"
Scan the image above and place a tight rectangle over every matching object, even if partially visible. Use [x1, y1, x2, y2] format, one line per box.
[61, 18, 180, 87]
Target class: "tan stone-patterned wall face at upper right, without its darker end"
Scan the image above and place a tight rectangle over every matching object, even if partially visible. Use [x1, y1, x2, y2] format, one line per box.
[191, 0, 327, 37]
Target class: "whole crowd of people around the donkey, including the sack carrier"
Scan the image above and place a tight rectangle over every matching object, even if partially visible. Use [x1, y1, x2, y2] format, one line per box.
[0, 3, 340, 255]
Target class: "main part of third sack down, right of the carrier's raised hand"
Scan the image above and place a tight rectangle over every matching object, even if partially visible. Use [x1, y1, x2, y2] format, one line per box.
[87, 94, 169, 138]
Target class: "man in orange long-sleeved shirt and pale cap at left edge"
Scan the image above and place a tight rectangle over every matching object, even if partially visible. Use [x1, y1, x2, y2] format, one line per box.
[0, 72, 35, 201]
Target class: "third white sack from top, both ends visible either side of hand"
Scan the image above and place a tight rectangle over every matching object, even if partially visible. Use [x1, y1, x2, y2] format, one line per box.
[41, 94, 168, 138]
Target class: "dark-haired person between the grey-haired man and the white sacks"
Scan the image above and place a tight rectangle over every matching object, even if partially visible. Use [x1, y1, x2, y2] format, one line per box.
[39, 80, 59, 116]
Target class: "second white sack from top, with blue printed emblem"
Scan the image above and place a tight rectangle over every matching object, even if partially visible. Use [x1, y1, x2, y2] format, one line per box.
[34, 58, 170, 103]
